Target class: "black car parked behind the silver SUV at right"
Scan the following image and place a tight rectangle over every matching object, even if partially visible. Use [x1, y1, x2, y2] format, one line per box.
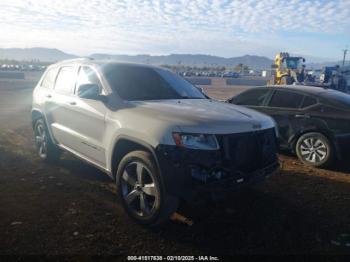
[227, 85, 350, 167]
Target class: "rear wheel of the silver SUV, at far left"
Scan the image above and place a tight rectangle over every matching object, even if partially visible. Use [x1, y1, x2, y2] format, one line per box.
[34, 119, 61, 162]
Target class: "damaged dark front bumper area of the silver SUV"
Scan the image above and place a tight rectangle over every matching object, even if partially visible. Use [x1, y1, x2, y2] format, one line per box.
[156, 128, 279, 200]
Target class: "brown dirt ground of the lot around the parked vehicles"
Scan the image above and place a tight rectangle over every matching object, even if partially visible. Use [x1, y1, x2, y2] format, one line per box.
[0, 75, 350, 256]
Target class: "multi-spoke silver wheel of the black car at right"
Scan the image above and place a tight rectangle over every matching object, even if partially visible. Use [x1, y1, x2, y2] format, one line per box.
[296, 132, 334, 167]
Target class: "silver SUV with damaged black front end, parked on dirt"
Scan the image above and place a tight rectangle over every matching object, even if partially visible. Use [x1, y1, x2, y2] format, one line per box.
[32, 59, 279, 224]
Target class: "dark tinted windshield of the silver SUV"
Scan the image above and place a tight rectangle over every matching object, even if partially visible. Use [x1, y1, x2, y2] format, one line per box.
[102, 64, 206, 101]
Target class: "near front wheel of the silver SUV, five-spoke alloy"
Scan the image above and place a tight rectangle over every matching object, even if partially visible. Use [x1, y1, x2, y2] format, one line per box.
[116, 151, 177, 225]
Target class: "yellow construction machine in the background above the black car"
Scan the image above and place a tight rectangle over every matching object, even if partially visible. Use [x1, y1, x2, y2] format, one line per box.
[269, 52, 306, 85]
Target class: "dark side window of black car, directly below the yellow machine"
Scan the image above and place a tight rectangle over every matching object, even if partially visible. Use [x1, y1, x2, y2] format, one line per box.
[269, 90, 304, 108]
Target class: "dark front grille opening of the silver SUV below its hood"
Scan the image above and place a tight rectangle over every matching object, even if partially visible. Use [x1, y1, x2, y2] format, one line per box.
[217, 128, 277, 173]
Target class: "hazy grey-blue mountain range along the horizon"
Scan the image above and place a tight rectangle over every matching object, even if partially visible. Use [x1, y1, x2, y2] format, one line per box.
[0, 47, 344, 69]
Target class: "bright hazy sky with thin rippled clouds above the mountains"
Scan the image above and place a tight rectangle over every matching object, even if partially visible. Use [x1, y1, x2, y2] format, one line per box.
[0, 0, 350, 59]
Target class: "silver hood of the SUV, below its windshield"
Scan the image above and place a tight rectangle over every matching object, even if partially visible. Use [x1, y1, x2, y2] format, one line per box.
[130, 99, 275, 134]
